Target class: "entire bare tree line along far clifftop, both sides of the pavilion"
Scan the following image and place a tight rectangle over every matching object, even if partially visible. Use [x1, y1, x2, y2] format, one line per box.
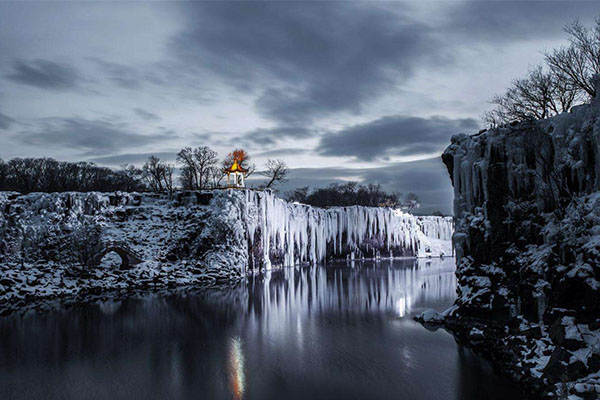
[0, 152, 426, 211]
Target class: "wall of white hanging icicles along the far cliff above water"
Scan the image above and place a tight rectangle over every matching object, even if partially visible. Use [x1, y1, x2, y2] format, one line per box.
[224, 190, 453, 268]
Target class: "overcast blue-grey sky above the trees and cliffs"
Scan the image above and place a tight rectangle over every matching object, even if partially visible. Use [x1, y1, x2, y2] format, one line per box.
[0, 1, 600, 212]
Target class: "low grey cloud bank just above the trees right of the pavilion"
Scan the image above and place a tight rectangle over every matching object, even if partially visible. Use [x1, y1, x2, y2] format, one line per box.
[250, 157, 453, 214]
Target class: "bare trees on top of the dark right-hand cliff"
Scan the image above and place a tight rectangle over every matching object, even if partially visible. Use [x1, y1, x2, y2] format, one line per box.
[484, 18, 600, 127]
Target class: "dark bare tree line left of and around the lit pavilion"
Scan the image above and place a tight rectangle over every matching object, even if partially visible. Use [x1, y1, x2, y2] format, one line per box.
[0, 146, 289, 193]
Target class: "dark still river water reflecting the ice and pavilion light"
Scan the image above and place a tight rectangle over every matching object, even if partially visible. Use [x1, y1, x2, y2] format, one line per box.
[0, 259, 522, 400]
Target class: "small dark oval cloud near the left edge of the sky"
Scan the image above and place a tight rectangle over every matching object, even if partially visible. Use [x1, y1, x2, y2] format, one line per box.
[7, 59, 80, 90]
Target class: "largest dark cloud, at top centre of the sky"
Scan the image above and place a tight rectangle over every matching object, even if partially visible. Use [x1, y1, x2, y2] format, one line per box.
[172, 2, 450, 125]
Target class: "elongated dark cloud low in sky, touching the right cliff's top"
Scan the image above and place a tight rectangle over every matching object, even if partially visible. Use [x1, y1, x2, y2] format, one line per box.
[317, 115, 479, 161]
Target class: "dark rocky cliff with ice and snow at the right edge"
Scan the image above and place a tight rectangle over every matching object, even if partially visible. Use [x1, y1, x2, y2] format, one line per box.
[442, 88, 600, 399]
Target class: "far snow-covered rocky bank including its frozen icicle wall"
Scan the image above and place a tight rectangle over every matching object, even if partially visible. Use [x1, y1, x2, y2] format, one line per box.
[0, 190, 453, 311]
